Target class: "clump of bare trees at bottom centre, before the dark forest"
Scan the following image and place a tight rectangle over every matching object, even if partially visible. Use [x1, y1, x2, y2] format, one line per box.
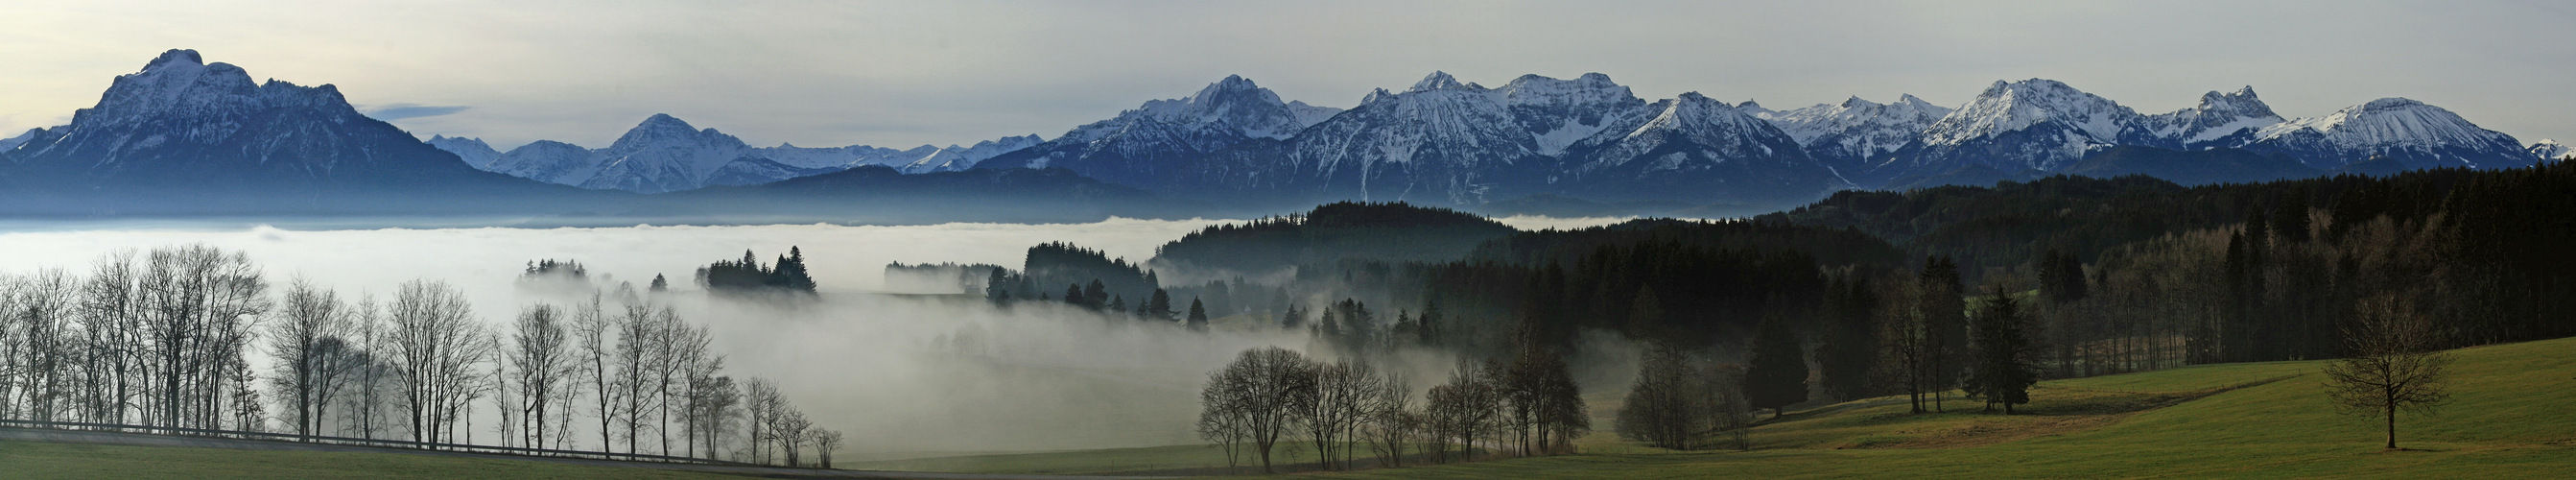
[1198, 346, 1592, 472]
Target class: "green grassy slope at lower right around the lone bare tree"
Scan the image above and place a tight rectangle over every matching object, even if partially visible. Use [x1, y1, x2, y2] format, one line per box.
[1319, 338, 2576, 477]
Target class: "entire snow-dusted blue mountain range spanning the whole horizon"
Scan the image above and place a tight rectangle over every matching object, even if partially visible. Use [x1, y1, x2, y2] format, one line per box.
[0, 49, 2565, 219]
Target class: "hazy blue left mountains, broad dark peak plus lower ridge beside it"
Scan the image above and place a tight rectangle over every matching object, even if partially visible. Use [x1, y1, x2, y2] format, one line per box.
[0, 49, 1179, 225]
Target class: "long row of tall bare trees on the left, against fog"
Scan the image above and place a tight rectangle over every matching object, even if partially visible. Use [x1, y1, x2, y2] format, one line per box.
[0, 245, 842, 468]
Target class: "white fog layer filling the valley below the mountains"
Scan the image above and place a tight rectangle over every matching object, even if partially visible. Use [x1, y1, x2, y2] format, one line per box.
[0, 217, 1631, 451]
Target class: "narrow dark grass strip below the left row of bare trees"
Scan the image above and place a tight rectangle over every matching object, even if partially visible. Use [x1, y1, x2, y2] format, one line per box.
[0, 442, 729, 480]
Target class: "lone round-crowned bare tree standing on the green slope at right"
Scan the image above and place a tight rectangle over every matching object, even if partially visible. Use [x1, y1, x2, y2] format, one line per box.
[2324, 297, 2452, 449]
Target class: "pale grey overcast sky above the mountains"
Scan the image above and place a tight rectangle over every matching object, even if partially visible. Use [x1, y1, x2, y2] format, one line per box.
[0, 0, 2576, 150]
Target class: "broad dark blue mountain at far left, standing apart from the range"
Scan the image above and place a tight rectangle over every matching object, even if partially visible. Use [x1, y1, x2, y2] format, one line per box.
[5, 49, 574, 214]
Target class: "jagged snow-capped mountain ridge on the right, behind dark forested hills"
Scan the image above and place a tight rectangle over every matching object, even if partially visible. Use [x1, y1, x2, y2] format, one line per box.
[977, 72, 2540, 206]
